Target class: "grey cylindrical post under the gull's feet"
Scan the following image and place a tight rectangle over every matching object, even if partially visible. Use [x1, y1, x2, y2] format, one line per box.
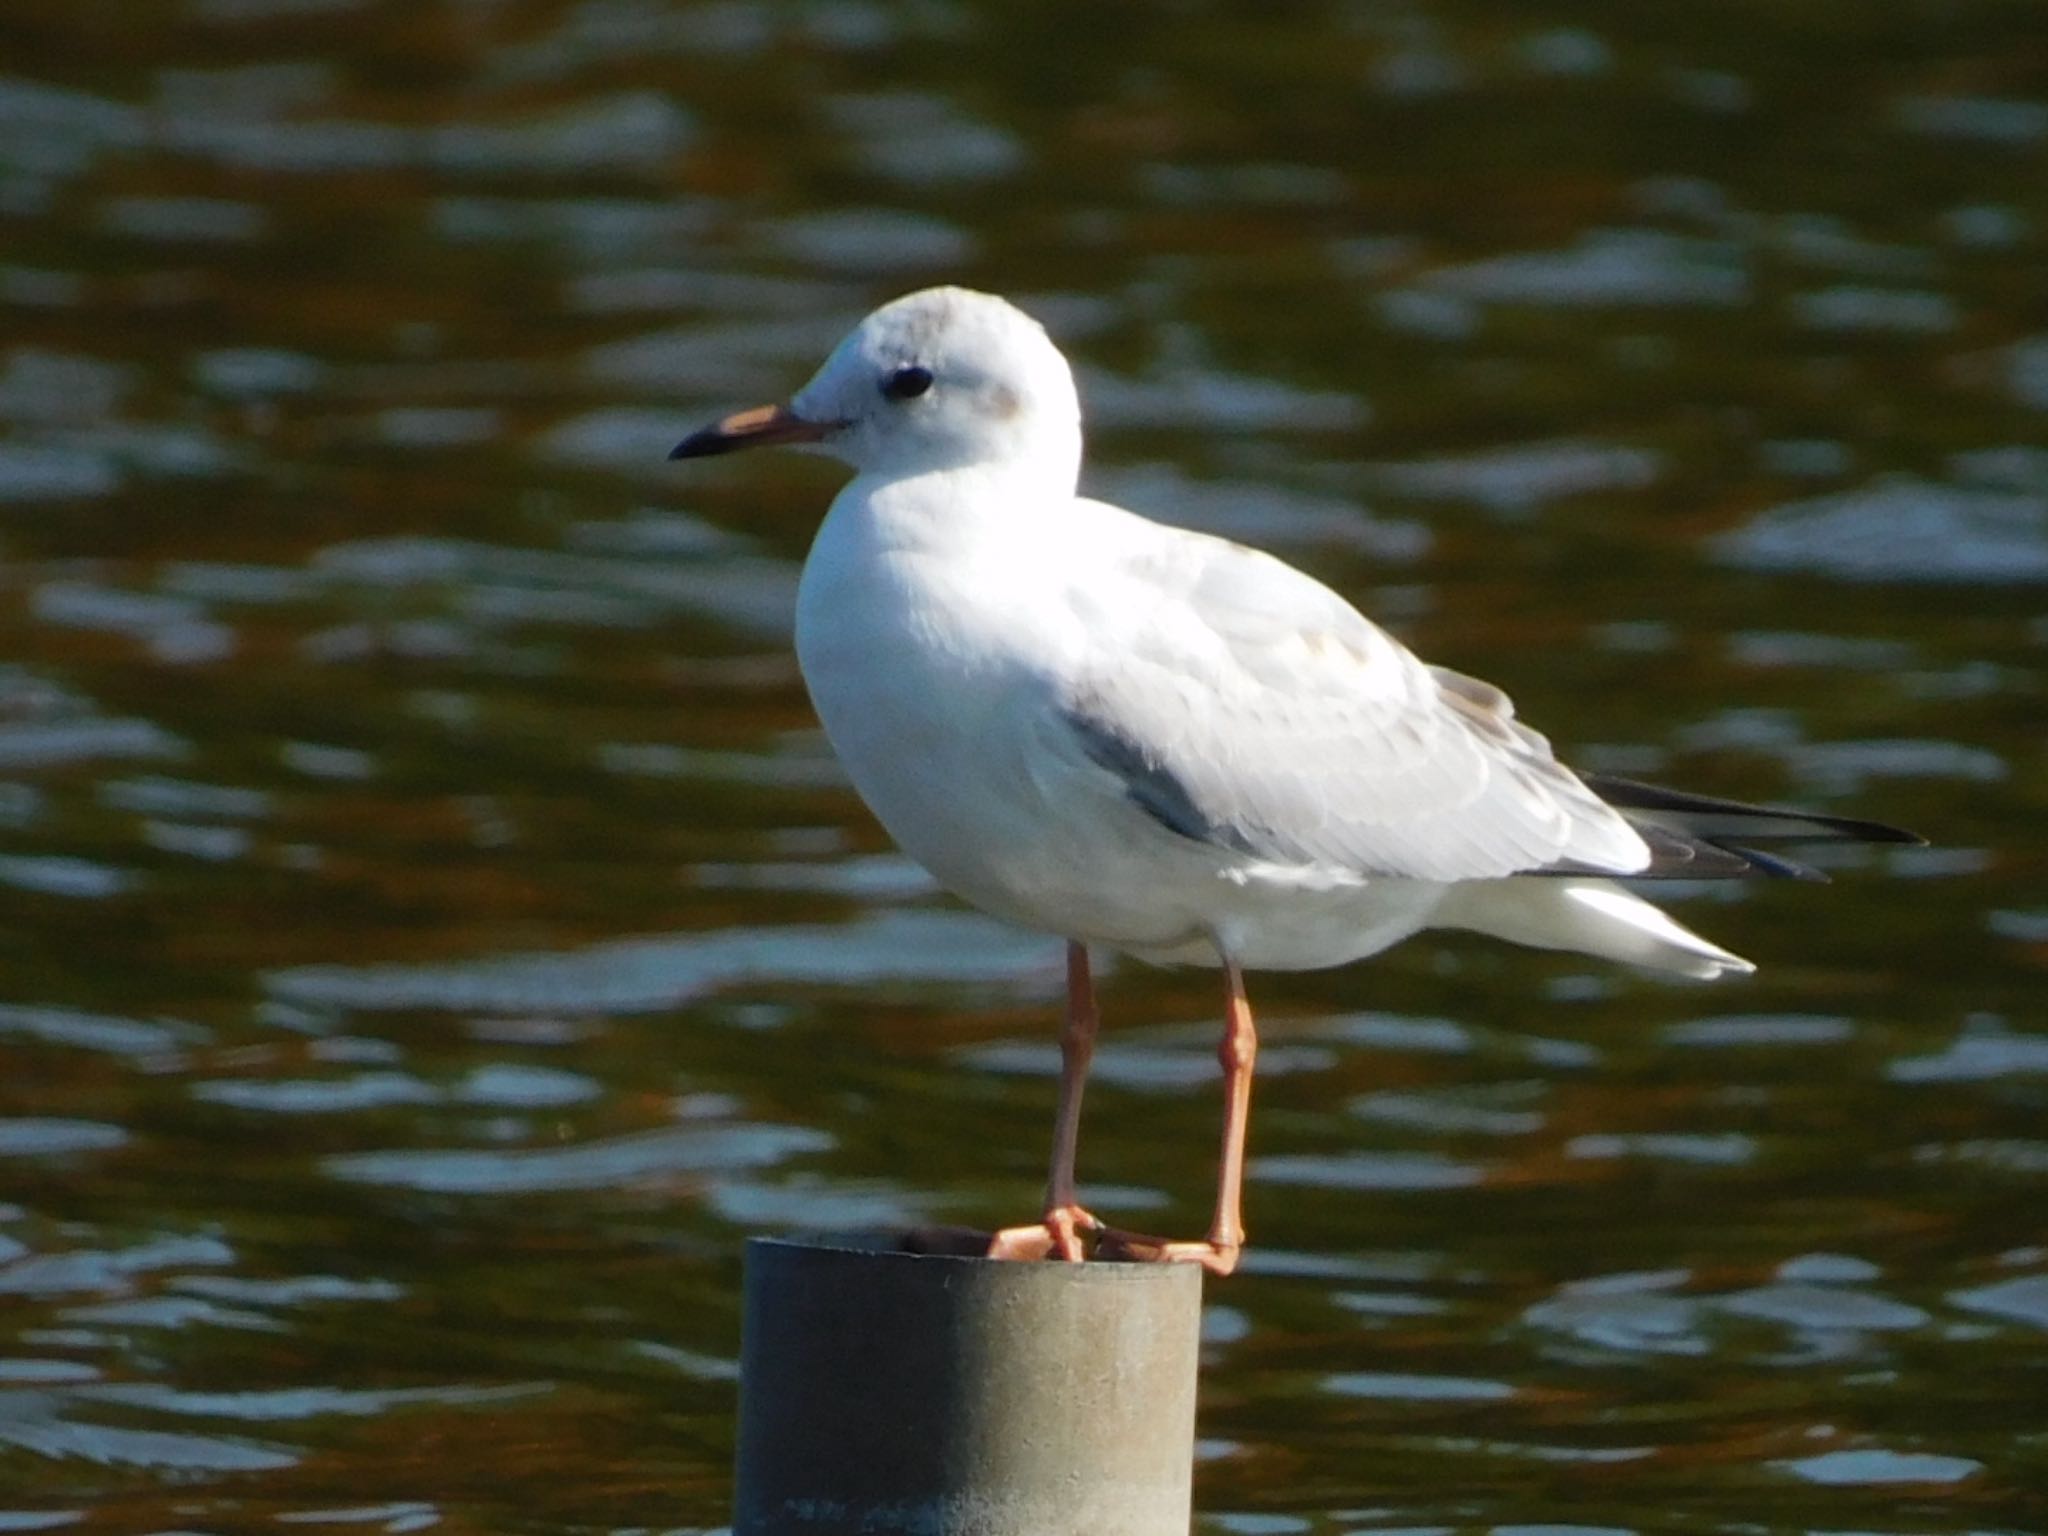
[733, 1239, 1202, 1536]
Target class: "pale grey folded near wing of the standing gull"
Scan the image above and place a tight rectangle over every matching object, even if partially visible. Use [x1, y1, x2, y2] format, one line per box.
[1059, 514, 1651, 881]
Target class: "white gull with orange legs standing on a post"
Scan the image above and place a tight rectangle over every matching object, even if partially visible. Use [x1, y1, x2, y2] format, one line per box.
[670, 287, 1921, 1274]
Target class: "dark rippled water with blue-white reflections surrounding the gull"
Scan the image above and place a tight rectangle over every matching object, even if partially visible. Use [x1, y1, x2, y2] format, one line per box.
[0, 0, 2048, 1536]
